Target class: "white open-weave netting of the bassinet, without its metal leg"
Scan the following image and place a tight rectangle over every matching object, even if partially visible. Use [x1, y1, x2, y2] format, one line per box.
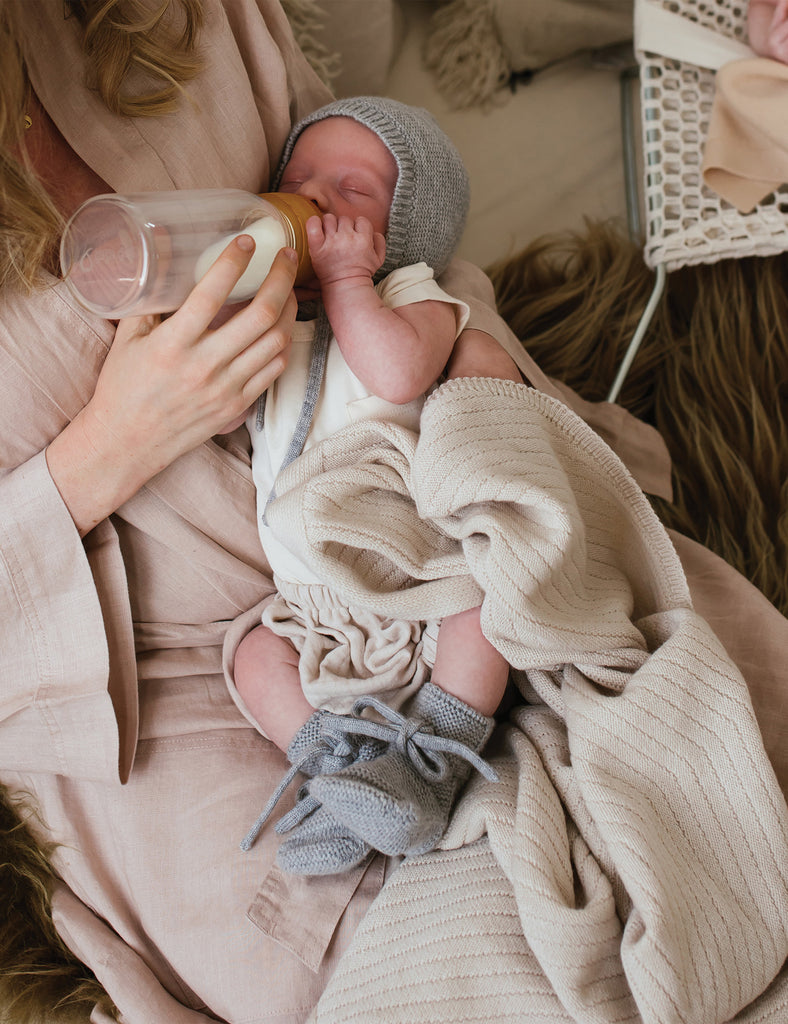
[637, 0, 788, 271]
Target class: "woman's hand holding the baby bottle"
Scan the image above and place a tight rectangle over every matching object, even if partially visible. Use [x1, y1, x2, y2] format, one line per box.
[47, 236, 296, 535]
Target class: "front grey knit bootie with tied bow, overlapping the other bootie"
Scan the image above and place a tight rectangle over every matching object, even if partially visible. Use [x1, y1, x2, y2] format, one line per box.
[306, 683, 497, 855]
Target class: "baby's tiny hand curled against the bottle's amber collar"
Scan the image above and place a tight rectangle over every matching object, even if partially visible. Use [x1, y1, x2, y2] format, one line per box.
[306, 213, 386, 287]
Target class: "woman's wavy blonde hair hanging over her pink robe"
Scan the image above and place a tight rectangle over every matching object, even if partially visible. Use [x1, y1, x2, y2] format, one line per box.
[0, 0, 203, 289]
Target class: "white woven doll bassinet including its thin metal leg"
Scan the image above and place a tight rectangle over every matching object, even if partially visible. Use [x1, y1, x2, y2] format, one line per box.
[607, 0, 788, 401]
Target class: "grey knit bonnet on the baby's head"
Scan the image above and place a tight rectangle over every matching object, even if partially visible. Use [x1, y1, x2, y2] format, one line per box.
[273, 96, 470, 281]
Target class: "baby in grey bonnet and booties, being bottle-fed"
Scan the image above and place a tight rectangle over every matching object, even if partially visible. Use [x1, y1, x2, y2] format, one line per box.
[234, 97, 521, 874]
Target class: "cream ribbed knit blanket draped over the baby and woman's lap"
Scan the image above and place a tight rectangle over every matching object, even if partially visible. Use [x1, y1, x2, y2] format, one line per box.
[269, 379, 788, 1024]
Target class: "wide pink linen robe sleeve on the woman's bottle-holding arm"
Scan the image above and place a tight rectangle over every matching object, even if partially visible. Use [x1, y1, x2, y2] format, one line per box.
[0, 289, 136, 778]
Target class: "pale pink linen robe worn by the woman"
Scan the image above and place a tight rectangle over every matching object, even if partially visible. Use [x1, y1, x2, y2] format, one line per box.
[0, 0, 384, 1024]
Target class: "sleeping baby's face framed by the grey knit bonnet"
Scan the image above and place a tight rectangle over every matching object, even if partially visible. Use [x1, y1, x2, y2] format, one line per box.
[279, 117, 398, 234]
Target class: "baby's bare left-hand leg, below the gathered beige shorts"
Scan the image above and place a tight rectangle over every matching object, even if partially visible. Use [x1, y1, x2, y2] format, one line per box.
[233, 626, 314, 752]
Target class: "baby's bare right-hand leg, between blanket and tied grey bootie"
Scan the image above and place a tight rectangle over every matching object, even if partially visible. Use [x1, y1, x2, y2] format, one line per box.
[425, 608, 509, 718]
